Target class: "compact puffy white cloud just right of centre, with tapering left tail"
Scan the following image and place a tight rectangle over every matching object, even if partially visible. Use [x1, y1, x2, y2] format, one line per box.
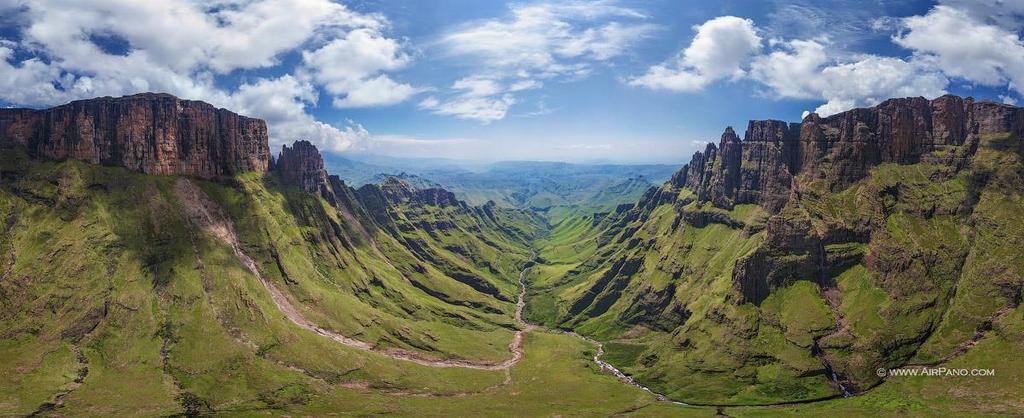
[630, 16, 761, 91]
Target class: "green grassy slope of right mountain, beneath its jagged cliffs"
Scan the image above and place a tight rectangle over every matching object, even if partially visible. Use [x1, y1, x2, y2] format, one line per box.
[527, 131, 1024, 412]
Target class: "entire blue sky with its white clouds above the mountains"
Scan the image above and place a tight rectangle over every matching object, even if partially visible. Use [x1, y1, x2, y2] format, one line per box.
[0, 0, 1024, 163]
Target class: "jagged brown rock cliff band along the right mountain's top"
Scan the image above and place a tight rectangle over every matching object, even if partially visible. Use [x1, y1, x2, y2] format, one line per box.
[671, 95, 1024, 212]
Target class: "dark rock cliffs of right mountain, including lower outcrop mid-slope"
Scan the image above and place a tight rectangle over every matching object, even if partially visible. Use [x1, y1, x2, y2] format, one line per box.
[659, 95, 1024, 303]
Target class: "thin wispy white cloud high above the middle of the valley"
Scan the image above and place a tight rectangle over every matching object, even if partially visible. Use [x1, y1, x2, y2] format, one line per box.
[420, 1, 656, 123]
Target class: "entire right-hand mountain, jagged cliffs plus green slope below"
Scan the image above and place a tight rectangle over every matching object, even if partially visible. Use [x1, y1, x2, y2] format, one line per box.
[530, 96, 1024, 404]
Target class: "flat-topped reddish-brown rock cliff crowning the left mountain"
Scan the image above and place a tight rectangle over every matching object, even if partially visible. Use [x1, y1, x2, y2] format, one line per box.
[0, 93, 270, 178]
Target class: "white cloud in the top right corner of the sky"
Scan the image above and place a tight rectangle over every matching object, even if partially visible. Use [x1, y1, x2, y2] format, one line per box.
[893, 2, 1024, 92]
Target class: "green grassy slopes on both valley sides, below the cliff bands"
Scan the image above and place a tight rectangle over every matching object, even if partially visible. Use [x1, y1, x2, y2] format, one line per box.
[0, 130, 1024, 416]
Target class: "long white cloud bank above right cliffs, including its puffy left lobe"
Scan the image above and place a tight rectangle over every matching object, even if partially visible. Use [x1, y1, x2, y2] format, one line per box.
[629, 16, 949, 116]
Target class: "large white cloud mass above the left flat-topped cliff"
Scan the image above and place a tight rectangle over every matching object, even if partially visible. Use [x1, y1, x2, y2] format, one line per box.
[0, 0, 418, 150]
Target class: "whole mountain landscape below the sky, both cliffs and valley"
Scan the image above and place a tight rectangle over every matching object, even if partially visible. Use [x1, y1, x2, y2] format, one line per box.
[0, 93, 1024, 416]
